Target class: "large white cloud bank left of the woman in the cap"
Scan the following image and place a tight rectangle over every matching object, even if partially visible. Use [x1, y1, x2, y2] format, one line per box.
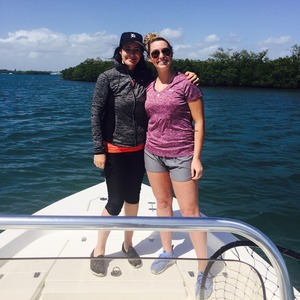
[0, 28, 118, 71]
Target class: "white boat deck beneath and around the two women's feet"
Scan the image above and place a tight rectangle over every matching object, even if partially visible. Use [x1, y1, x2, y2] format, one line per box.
[0, 184, 300, 300]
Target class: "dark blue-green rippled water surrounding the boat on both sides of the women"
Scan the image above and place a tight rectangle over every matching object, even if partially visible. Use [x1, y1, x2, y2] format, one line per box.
[0, 74, 300, 286]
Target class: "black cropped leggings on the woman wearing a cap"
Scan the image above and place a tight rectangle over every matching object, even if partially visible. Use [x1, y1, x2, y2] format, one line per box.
[104, 150, 145, 216]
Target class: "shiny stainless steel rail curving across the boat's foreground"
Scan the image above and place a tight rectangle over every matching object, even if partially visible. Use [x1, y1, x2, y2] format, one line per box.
[0, 215, 294, 300]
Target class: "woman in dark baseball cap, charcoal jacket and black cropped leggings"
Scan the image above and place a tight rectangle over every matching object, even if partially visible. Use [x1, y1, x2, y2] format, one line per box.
[90, 32, 198, 276]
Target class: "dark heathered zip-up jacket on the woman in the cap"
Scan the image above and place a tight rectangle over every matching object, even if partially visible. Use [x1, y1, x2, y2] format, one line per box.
[91, 63, 153, 154]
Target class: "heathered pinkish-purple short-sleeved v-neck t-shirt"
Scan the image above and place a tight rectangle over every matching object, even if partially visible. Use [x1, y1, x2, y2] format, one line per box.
[145, 73, 202, 157]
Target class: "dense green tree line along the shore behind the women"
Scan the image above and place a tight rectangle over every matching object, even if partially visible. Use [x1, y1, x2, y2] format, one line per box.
[61, 45, 300, 89]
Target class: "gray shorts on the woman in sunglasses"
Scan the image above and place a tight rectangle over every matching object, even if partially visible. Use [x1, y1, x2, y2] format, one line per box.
[144, 150, 193, 182]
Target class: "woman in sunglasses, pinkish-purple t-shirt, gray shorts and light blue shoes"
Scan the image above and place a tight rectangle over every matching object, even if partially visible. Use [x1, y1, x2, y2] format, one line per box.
[144, 33, 212, 298]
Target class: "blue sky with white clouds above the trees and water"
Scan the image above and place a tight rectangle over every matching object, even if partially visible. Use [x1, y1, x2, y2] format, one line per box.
[0, 0, 300, 71]
